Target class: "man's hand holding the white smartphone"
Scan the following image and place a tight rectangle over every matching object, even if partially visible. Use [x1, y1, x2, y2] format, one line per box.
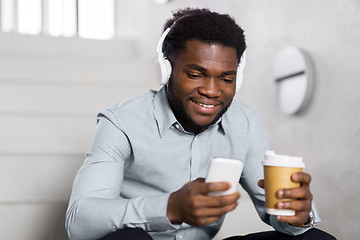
[167, 178, 240, 226]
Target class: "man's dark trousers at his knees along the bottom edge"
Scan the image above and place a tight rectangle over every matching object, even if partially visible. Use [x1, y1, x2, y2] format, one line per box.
[101, 228, 336, 240]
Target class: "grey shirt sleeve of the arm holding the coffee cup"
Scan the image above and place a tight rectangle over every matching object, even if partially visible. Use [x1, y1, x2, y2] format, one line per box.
[240, 110, 320, 235]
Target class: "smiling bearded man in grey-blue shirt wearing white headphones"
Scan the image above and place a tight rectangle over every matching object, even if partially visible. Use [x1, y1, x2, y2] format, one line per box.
[66, 9, 334, 240]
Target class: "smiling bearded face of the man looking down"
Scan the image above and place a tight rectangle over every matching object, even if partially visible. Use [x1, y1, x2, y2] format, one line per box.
[167, 40, 238, 133]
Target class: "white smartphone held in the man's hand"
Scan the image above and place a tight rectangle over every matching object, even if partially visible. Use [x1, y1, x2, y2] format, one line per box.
[205, 158, 244, 196]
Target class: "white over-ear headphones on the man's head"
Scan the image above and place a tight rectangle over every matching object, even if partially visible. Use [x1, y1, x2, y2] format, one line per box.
[156, 27, 246, 91]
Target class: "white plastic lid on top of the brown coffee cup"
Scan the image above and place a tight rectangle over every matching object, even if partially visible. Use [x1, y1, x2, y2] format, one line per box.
[263, 151, 305, 168]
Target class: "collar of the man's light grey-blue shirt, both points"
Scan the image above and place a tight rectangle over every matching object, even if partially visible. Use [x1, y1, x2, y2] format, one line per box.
[153, 86, 226, 137]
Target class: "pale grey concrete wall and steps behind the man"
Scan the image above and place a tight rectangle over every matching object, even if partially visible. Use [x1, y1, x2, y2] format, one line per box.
[0, 0, 360, 240]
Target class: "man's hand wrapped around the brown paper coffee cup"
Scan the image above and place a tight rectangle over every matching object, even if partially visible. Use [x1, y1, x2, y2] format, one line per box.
[258, 172, 313, 227]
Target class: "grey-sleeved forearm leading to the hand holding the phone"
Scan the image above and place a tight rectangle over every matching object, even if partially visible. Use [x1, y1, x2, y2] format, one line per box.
[66, 194, 175, 240]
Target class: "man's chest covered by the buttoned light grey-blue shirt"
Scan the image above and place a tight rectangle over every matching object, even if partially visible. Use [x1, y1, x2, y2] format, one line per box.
[124, 124, 247, 192]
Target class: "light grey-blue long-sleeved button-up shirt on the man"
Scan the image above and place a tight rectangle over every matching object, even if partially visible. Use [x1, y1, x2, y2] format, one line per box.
[66, 87, 318, 240]
